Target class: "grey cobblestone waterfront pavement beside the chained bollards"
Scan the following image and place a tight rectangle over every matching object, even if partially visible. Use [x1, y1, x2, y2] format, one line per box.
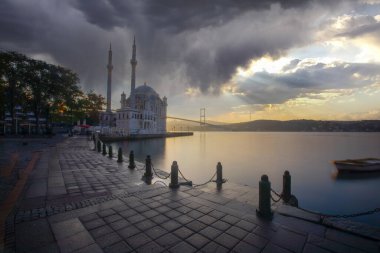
[6, 137, 380, 253]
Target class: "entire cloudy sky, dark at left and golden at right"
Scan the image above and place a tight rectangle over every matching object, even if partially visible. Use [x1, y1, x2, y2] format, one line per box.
[0, 0, 380, 122]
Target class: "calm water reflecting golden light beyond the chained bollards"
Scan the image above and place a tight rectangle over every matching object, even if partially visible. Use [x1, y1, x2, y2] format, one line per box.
[114, 132, 380, 226]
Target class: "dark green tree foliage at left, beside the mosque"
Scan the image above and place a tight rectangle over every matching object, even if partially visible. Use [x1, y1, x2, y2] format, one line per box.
[0, 51, 105, 131]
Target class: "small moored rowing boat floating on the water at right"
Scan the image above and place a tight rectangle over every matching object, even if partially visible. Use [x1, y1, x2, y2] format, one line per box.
[334, 158, 380, 172]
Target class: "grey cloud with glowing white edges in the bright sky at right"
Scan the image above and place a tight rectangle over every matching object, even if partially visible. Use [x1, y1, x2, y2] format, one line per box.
[236, 60, 380, 104]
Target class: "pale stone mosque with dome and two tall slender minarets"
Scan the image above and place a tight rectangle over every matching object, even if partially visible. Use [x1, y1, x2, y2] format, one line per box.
[100, 39, 168, 135]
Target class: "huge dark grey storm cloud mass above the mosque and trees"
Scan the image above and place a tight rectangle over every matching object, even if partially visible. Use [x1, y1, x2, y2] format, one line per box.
[0, 0, 350, 98]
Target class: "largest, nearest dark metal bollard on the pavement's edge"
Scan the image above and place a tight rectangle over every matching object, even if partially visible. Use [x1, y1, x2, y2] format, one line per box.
[256, 175, 273, 219]
